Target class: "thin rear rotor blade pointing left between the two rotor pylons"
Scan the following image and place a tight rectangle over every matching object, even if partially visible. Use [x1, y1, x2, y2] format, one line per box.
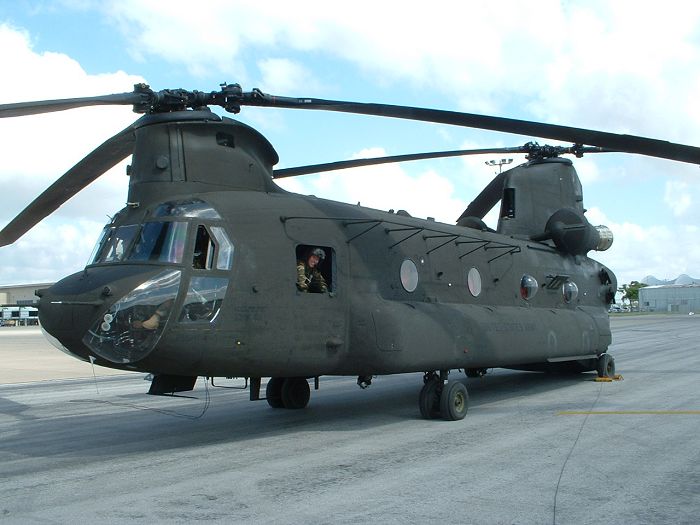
[272, 146, 524, 179]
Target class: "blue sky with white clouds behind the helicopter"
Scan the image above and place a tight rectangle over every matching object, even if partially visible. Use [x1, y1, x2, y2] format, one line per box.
[0, 0, 700, 285]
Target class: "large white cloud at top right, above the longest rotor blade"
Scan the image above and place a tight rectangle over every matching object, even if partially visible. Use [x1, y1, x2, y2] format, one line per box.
[98, 0, 700, 140]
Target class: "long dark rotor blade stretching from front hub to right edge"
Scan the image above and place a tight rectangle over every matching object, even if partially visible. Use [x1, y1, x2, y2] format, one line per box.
[241, 91, 700, 164]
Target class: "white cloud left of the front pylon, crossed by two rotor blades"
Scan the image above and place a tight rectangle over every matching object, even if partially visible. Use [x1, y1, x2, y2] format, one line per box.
[0, 25, 143, 283]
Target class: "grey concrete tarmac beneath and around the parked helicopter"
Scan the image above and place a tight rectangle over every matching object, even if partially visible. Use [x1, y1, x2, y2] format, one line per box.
[0, 315, 700, 524]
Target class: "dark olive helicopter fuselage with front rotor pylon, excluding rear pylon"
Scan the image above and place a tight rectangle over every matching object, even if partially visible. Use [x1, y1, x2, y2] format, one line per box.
[35, 112, 614, 377]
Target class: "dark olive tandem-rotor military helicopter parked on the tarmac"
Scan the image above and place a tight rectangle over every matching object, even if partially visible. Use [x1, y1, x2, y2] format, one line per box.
[0, 84, 700, 420]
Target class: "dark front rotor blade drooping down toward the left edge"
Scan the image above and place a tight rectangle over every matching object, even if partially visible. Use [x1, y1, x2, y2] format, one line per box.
[0, 124, 135, 246]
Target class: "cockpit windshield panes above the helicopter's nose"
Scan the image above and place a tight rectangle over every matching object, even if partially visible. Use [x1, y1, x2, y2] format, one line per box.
[89, 222, 187, 264]
